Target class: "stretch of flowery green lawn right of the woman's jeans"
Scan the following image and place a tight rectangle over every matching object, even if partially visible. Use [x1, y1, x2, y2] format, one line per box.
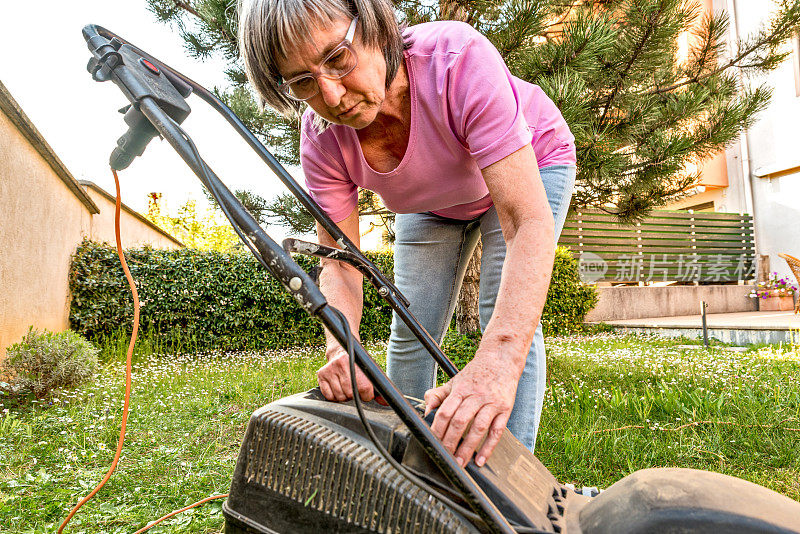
[537, 335, 800, 500]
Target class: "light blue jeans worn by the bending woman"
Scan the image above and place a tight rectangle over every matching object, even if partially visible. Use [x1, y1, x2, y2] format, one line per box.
[387, 165, 575, 451]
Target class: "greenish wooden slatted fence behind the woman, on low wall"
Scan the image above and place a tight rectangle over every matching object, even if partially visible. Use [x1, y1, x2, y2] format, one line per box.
[558, 210, 755, 282]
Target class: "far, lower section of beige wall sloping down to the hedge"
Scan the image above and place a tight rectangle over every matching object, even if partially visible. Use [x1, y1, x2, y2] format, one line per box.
[83, 185, 181, 249]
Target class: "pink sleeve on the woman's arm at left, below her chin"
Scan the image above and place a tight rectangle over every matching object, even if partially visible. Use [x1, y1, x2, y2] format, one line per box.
[300, 117, 358, 223]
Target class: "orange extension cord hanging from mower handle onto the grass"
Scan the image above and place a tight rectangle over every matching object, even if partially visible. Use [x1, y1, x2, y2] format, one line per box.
[58, 169, 228, 534]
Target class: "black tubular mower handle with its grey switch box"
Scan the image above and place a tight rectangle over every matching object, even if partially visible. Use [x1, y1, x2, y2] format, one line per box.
[78, 25, 515, 534]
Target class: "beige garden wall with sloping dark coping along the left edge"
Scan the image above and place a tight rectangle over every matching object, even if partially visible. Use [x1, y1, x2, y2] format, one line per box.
[0, 83, 181, 362]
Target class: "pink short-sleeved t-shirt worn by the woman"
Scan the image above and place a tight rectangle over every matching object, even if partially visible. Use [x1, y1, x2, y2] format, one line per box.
[300, 22, 575, 222]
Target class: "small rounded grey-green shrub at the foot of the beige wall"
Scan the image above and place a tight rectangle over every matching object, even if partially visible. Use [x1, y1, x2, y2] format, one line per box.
[5, 327, 97, 398]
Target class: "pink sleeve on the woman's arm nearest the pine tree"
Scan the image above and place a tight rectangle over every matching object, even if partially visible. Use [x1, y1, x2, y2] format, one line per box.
[448, 30, 533, 169]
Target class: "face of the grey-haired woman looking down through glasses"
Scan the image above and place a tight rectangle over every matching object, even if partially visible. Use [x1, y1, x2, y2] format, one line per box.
[277, 18, 386, 129]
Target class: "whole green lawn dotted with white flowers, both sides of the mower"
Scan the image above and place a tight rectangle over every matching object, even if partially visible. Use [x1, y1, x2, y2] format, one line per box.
[0, 334, 800, 533]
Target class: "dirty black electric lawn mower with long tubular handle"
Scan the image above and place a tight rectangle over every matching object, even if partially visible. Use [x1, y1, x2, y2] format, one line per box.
[83, 25, 800, 534]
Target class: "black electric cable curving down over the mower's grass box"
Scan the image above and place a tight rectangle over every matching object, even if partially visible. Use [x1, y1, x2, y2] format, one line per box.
[332, 308, 552, 534]
